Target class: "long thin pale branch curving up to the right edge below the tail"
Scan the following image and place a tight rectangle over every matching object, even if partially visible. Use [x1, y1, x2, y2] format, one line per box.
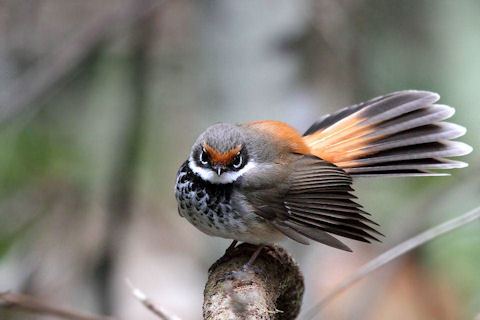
[304, 207, 480, 319]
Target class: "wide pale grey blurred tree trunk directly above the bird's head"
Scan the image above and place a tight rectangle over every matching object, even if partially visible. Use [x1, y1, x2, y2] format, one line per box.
[198, 0, 308, 124]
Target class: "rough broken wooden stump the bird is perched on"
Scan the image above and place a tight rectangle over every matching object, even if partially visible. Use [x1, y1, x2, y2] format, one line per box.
[203, 244, 304, 320]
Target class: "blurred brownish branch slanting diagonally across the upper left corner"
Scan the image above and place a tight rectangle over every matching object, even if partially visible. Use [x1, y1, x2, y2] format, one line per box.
[0, 0, 163, 123]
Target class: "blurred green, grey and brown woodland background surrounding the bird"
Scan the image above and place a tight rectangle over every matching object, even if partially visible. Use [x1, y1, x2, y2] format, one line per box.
[0, 0, 480, 319]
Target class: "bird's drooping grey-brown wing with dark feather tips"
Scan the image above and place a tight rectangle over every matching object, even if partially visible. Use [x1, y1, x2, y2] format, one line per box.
[245, 155, 379, 251]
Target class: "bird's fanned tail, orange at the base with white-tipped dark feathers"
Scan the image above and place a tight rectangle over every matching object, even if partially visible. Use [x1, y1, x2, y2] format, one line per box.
[303, 90, 472, 176]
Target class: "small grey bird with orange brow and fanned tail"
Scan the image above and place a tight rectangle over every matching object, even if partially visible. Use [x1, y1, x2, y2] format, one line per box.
[175, 90, 472, 266]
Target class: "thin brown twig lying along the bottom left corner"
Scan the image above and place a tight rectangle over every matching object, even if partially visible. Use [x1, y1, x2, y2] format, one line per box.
[0, 292, 113, 320]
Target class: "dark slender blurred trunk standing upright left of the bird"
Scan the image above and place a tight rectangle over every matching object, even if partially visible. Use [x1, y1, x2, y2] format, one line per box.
[95, 0, 155, 314]
